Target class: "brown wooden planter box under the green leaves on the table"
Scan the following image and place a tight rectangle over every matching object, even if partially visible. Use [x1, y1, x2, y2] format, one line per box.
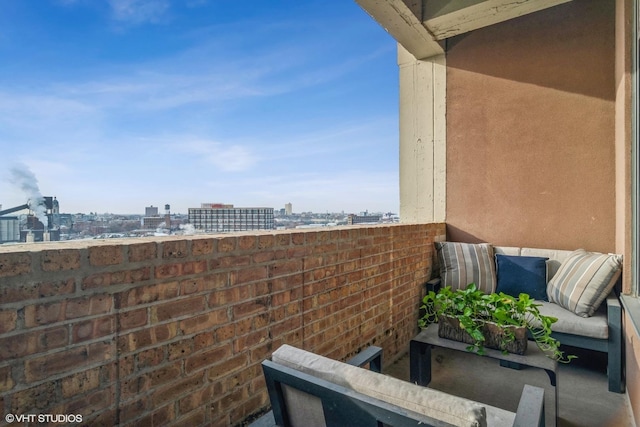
[438, 316, 528, 354]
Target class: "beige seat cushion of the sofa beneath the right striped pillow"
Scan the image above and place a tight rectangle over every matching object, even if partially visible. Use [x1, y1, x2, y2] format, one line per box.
[538, 302, 609, 340]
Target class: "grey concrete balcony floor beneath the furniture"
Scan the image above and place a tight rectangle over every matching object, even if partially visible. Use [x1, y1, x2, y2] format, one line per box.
[384, 342, 634, 427]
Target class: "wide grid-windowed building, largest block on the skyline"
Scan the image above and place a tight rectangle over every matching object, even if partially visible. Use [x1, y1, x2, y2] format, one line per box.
[189, 203, 274, 232]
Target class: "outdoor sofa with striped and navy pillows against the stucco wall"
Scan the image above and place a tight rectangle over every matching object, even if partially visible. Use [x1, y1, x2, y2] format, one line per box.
[429, 242, 624, 393]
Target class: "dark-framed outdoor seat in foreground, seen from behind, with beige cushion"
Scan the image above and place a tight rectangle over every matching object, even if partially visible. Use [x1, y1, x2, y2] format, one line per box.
[252, 344, 544, 427]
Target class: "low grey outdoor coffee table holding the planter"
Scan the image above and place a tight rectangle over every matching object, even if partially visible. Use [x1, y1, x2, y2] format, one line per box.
[409, 326, 558, 423]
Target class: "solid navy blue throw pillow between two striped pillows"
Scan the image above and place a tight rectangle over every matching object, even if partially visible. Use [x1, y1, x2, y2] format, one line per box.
[496, 254, 549, 301]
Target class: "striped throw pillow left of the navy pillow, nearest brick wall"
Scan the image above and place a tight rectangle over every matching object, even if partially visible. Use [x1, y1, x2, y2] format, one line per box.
[435, 242, 496, 294]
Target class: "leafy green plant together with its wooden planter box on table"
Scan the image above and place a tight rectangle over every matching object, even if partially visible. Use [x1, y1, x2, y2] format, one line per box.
[419, 283, 575, 362]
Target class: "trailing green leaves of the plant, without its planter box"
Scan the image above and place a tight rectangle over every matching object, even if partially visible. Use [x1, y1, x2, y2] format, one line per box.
[418, 283, 576, 362]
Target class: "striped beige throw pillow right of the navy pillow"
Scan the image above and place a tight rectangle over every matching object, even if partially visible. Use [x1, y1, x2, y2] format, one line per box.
[547, 249, 622, 317]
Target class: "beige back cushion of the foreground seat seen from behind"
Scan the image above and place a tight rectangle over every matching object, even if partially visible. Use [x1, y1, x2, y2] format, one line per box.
[271, 344, 487, 427]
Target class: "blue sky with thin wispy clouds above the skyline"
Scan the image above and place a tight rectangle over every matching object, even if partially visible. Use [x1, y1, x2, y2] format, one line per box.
[0, 0, 399, 213]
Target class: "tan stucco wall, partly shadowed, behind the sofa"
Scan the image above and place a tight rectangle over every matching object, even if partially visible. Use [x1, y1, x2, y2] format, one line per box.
[446, 0, 616, 252]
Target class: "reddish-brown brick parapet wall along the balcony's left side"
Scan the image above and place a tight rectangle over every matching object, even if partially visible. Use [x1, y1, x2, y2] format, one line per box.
[0, 224, 445, 426]
